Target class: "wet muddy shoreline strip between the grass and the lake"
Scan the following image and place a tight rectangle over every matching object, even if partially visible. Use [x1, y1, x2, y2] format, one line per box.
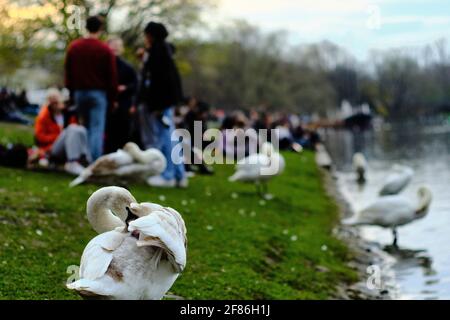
[323, 170, 399, 300]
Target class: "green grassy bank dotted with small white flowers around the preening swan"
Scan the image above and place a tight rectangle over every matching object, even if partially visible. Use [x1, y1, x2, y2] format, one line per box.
[0, 123, 356, 299]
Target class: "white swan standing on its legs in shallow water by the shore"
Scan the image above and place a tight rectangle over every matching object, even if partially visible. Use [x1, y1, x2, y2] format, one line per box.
[343, 187, 432, 247]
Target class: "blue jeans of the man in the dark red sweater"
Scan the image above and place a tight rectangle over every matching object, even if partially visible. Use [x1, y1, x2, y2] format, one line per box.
[74, 90, 108, 160]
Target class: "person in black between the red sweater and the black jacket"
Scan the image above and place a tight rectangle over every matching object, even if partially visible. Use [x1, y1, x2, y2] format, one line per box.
[105, 38, 138, 153]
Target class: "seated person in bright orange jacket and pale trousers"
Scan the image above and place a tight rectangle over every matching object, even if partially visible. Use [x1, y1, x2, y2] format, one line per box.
[35, 89, 91, 175]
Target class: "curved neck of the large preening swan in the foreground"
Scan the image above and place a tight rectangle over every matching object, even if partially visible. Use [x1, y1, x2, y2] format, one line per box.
[86, 188, 136, 233]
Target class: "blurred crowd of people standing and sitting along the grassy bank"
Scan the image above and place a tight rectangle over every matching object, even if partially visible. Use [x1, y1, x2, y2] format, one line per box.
[0, 16, 319, 187]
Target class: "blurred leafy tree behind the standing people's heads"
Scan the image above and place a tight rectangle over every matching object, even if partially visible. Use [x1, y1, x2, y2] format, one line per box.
[0, 0, 213, 85]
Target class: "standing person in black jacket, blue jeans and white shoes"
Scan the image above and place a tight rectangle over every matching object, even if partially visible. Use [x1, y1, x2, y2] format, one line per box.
[138, 22, 188, 187]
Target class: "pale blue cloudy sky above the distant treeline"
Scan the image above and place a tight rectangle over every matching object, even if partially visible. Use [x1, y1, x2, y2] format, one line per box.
[206, 0, 450, 59]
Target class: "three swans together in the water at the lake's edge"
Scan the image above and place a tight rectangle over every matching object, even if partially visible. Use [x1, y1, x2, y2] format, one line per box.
[344, 153, 432, 247]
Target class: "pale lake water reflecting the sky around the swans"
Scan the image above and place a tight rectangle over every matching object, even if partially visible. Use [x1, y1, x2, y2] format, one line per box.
[324, 127, 450, 299]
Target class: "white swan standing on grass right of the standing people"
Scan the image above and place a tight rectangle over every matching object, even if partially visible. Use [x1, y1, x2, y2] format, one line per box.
[228, 142, 285, 198]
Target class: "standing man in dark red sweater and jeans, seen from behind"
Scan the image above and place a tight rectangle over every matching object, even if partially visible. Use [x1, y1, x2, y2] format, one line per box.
[65, 16, 118, 160]
